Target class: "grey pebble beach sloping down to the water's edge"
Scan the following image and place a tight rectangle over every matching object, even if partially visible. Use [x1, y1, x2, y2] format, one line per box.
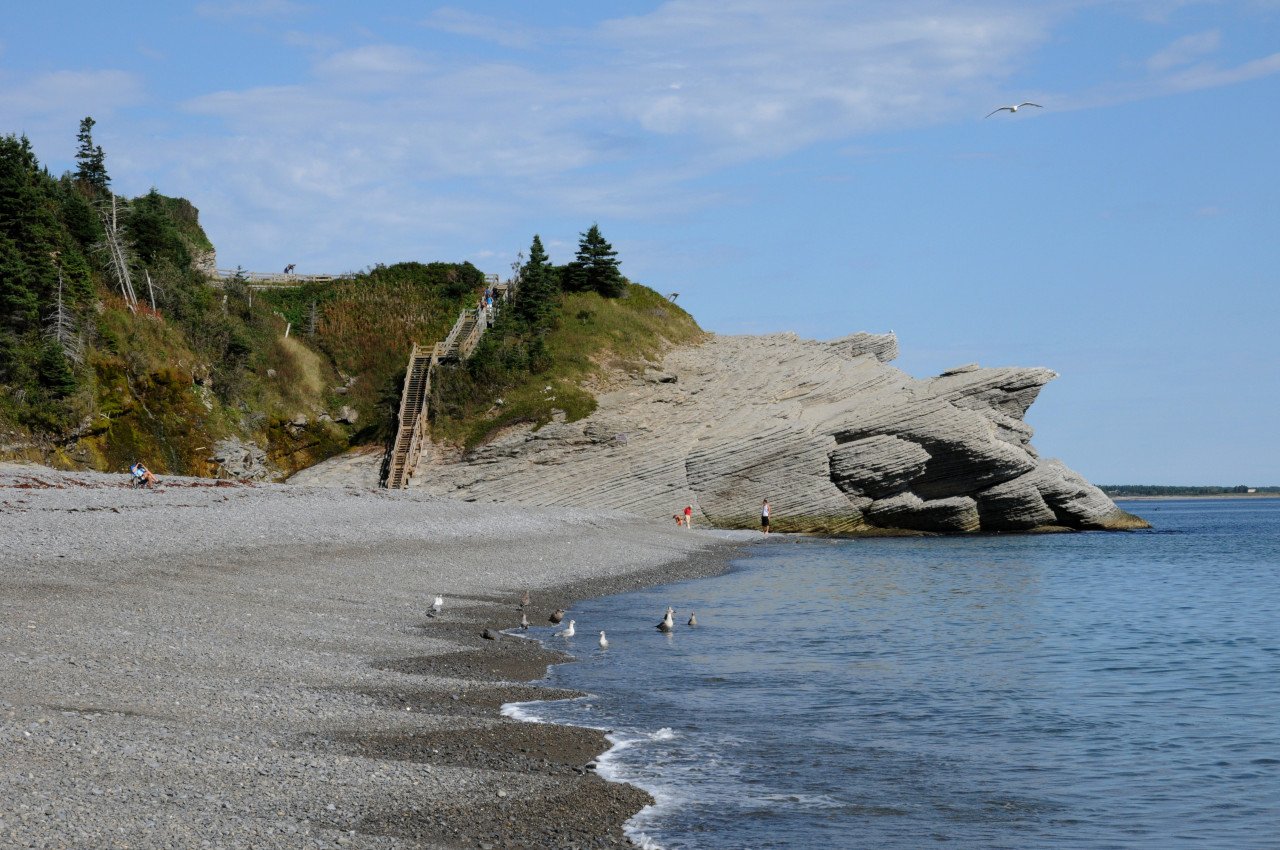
[0, 465, 735, 849]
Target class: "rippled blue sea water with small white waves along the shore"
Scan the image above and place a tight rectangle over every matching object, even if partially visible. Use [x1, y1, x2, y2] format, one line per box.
[508, 499, 1280, 850]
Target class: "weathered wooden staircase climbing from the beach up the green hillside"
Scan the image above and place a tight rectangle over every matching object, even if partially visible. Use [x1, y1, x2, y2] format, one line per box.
[383, 275, 516, 490]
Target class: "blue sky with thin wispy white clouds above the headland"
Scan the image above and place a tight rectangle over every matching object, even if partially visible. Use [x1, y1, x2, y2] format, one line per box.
[0, 0, 1280, 485]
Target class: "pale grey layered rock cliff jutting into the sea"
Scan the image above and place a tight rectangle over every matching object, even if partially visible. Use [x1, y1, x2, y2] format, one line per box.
[401, 334, 1146, 533]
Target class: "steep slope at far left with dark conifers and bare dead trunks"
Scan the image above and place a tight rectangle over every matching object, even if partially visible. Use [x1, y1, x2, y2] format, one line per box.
[0, 118, 368, 475]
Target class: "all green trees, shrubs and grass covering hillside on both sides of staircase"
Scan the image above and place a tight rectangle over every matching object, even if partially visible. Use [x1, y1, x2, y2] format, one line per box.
[0, 118, 701, 475]
